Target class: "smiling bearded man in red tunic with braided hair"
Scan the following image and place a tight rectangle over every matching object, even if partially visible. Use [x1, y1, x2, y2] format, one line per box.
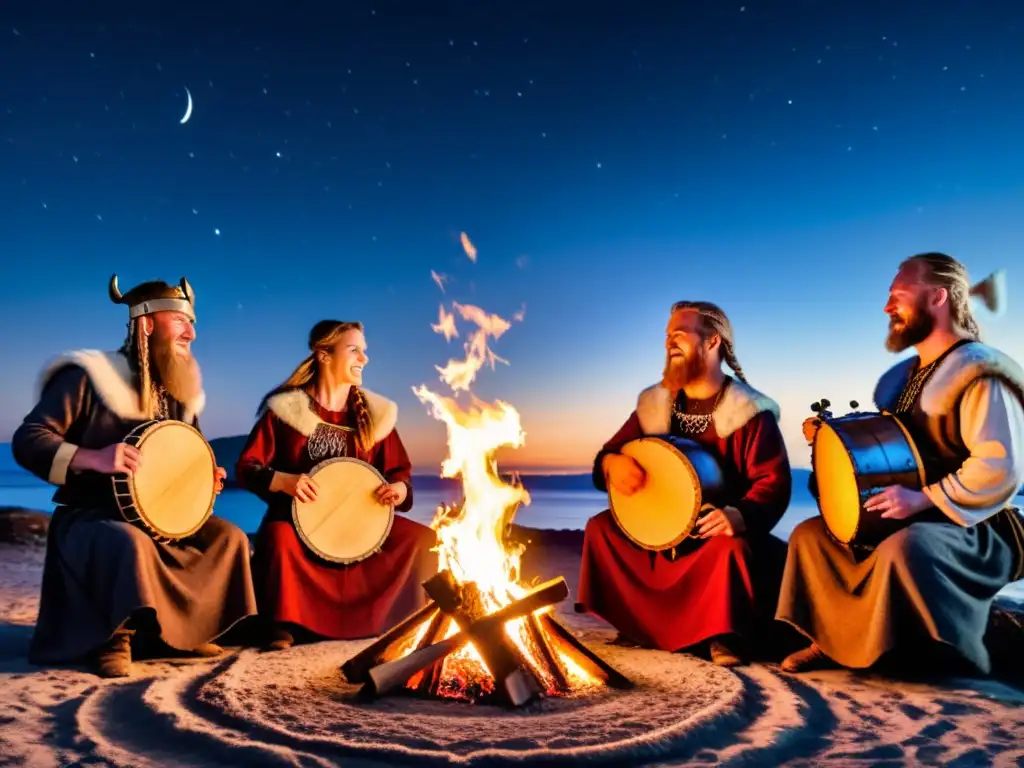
[577, 301, 793, 666]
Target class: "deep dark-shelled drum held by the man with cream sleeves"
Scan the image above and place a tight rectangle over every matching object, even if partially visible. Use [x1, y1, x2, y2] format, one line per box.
[811, 413, 925, 547]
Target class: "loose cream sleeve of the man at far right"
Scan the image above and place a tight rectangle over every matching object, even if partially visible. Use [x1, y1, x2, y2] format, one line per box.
[923, 378, 1024, 526]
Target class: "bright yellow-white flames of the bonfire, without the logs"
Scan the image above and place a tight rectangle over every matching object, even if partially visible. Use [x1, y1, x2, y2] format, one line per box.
[398, 280, 601, 698]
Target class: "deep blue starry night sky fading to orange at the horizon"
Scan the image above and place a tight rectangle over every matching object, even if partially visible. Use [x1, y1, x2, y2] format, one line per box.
[0, 0, 1024, 472]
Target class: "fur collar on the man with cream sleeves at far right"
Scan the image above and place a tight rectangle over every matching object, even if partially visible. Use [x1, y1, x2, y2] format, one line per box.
[874, 341, 1024, 415]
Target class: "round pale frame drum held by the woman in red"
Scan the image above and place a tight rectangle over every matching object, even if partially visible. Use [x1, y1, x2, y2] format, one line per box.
[292, 456, 394, 563]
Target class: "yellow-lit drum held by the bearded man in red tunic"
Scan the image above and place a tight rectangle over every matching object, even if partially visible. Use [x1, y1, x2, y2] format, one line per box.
[608, 435, 725, 552]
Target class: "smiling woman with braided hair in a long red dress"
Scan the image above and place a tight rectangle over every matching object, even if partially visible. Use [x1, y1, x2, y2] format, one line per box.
[237, 321, 437, 650]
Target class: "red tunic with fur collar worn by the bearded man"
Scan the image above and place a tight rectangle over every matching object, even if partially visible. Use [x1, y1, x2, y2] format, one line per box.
[579, 381, 793, 651]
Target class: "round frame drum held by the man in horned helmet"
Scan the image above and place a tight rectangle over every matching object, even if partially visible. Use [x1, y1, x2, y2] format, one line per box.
[112, 420, 217, 541]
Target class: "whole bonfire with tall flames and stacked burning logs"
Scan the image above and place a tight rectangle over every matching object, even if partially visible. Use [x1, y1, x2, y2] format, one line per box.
[342, 236, 630, 706]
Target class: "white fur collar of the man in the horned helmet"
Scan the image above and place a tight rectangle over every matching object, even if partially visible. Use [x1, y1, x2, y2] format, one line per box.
[36, 349, 206, 424]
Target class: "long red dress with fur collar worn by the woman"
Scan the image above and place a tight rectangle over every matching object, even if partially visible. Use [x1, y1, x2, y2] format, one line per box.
[236, 390, 437, 640]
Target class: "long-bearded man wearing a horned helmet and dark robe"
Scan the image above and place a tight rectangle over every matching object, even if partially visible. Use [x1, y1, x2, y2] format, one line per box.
[11, 275, 256, 677]
